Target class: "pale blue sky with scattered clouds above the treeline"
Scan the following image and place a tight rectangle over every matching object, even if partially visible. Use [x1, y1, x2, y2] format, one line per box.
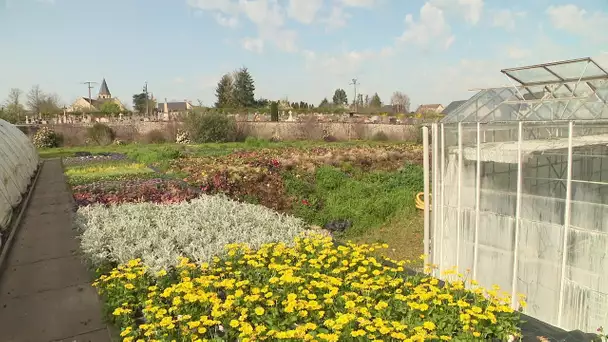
[0, 0, 608, 106]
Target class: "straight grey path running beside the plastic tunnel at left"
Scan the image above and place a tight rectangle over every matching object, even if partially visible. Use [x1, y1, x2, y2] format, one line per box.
[0, 159, 110, 342]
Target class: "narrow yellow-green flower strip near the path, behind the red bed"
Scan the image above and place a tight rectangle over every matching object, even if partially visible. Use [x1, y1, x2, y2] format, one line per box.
[65, 162, 157, 185]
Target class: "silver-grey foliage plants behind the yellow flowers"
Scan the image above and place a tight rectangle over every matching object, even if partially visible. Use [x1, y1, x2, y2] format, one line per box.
[75, 195, 306, 271]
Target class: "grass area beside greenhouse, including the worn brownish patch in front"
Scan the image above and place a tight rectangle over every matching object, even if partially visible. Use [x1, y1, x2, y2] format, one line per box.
[283, 165, 424, 267]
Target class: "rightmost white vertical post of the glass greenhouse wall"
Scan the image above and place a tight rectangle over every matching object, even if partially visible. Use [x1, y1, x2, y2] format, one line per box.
[557, 121, 574, 327]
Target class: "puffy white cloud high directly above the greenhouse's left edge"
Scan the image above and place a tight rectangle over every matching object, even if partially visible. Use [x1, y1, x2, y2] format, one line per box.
[399, 2, 454, 49]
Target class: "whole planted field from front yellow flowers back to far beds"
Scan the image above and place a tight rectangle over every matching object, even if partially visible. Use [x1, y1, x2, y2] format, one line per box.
[54, 142, 520, 342]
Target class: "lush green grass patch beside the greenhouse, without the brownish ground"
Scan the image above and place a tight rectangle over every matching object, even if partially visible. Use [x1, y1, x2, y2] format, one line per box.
[284, 165, 422, 237]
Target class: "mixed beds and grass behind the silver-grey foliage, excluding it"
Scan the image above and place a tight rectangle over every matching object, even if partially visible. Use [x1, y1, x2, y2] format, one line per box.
[60, 142, 423, 260]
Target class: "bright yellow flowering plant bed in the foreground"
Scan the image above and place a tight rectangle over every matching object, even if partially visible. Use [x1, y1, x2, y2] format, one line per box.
[93, 235, 520, 342]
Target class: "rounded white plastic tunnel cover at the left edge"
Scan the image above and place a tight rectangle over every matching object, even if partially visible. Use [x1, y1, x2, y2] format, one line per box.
[0, 120, 39, 232]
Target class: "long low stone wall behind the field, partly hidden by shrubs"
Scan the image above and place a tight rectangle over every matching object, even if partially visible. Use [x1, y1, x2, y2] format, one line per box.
[20, 122, 421, 146]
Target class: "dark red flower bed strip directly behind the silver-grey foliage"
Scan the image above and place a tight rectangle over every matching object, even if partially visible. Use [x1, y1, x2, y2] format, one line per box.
[72, 178, 198, 206]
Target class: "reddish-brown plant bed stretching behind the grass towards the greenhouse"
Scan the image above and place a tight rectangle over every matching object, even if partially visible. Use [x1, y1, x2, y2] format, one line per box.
[169, 145, 421, 212]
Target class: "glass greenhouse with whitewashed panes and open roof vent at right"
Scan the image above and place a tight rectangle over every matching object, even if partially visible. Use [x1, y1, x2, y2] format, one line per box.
[425, 58, 608, 332]
